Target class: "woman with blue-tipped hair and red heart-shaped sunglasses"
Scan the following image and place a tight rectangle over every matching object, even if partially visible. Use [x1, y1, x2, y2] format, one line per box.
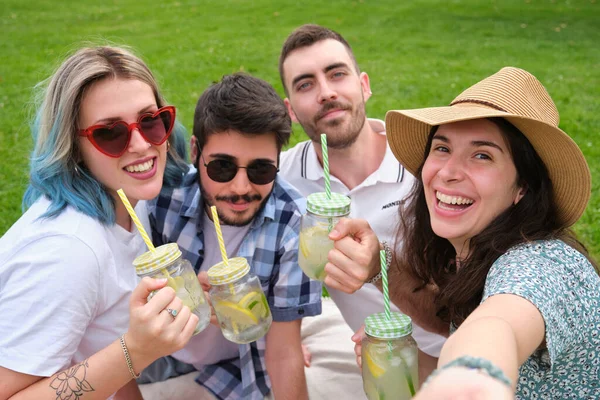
[0, 46, 197, 399]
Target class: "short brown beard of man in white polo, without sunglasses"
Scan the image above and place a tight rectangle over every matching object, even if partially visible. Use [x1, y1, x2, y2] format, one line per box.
[298, 100, 367, 150]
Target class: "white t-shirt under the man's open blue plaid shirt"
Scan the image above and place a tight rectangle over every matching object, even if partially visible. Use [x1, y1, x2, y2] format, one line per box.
[172, 211, 250, 370]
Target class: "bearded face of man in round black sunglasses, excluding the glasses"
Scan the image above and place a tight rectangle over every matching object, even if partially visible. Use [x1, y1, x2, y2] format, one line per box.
[196, 130, 279, 226]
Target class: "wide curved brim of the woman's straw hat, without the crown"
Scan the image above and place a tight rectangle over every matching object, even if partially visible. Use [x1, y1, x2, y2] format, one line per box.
[385, 105, 591, 227]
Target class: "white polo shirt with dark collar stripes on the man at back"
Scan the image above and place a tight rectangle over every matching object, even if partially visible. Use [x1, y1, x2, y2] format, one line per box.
[279, 119, 445, 357]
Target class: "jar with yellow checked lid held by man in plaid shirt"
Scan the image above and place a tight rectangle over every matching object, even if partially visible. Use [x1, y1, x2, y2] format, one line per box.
[208, 257, 273, 344]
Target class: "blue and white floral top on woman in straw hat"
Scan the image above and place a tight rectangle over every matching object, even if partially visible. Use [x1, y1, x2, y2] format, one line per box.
[482, 240, 600, 400]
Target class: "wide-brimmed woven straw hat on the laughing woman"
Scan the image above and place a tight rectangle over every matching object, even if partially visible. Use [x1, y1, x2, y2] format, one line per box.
[385, 67, 591, 227]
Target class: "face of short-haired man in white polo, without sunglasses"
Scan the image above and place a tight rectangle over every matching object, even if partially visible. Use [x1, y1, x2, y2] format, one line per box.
[283, 39, 371, 148]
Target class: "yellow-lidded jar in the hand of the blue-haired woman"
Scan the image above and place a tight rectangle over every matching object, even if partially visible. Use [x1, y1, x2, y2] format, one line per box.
[133, 243, 211, 335]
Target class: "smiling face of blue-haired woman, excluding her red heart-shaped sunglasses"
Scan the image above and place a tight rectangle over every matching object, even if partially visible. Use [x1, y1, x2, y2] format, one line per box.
[78, 78, 167, 208]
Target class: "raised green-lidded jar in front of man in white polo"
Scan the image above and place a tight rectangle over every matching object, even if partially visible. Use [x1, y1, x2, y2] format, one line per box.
[298, 192, 351, 281]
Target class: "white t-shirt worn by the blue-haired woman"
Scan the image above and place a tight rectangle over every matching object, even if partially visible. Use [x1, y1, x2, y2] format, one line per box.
[0, 198, 149, 377]
